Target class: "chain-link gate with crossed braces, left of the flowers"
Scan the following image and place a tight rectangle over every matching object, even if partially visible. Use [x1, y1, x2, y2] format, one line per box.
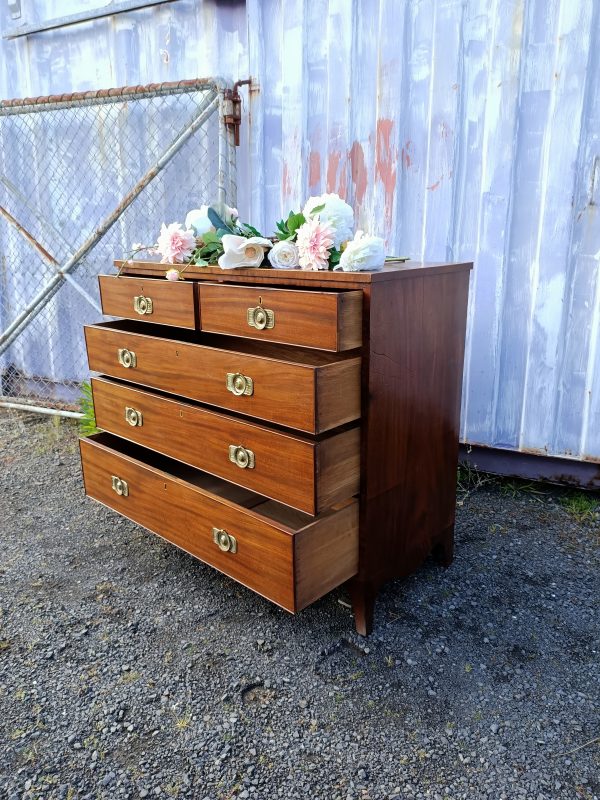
[0, 80, 236, 410]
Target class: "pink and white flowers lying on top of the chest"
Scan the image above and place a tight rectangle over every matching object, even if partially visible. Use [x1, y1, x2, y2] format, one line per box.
[125, 194, 386, 281]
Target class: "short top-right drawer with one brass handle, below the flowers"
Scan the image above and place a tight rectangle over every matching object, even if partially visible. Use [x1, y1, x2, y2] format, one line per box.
[198, 284, 362, 351]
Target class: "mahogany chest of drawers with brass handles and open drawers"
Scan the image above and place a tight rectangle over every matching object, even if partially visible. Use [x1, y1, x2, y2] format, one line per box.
[81, 262, 472, 634]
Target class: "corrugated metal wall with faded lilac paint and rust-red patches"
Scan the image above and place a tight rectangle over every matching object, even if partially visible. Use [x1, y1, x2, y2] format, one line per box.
[0, 0, 600, 460]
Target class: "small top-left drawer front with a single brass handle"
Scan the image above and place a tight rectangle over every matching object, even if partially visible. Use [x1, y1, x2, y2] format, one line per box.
[98, 275, 196, 328]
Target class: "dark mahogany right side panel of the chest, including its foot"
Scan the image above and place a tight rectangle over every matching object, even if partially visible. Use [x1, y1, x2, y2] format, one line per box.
[352, 268, 469, 634]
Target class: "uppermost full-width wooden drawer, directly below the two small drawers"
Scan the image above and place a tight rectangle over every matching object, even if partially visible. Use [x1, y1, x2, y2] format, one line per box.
[85, 321, 360, 433]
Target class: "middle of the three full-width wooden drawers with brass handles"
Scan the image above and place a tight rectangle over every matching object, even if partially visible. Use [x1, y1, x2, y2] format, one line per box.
[92, 378, 360, 515]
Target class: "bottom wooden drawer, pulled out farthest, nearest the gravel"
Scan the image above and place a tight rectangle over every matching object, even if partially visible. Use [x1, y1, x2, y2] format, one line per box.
[80, 433, 358, 611]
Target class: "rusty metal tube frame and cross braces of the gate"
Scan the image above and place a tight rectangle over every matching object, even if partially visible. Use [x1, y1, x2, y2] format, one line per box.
[0, 78, 239, 416]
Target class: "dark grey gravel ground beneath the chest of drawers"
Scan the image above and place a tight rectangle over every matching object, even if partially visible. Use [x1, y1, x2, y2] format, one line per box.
[0, 410, 600, 800]
